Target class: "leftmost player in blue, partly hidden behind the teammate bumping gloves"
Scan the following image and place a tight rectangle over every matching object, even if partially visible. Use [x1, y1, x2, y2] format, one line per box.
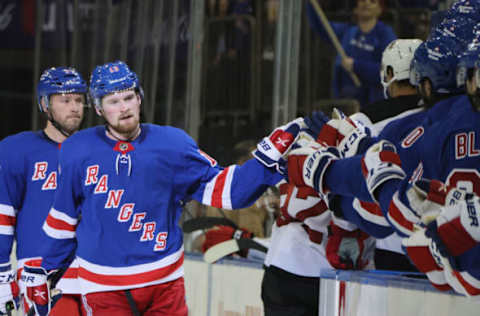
[0, 67, 87, 315]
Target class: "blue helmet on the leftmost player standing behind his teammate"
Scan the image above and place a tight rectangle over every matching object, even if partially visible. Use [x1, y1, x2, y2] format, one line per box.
[37, 67, 87, 112]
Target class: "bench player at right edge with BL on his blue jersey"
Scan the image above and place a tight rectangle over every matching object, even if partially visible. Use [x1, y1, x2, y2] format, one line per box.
[289, 40, 480, 296]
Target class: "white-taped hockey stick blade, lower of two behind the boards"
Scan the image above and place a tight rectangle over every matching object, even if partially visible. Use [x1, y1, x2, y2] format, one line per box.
[203, 238, 268, 263]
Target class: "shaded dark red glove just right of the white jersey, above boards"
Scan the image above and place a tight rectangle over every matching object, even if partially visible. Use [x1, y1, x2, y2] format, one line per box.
[325, 218, 375, 270]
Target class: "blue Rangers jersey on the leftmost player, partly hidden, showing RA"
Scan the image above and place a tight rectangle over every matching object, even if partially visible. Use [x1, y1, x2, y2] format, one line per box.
[0, 131, 78, 293]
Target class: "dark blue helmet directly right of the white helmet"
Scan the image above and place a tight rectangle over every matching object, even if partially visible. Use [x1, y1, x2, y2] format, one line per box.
[410, 38, 457, 93]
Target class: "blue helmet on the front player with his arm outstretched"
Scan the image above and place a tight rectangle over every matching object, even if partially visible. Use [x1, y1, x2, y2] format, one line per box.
[89, 61, 143, 108]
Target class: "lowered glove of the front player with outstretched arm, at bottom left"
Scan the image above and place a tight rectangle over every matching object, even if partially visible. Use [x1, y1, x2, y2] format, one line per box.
[22, 261, 62, 316]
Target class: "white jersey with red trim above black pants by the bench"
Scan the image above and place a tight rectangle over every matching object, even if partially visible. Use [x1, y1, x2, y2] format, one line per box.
[265, 182, 332, 277]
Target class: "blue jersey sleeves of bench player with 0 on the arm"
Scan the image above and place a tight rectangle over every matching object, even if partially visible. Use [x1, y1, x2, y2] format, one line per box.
[326, 96, 462, 238]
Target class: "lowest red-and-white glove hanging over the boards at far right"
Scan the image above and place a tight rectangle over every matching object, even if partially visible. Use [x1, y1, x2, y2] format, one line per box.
[402, 229, 452, 291]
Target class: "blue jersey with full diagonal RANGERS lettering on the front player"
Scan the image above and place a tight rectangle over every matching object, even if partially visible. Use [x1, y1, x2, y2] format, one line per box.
[42, 124, 282, 294]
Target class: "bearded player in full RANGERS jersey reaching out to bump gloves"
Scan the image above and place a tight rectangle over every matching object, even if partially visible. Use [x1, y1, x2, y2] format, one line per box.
[21, 62, 303, 315]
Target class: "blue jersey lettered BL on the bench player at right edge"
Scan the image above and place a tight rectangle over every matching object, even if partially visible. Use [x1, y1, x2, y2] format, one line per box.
[388, 95, 480, 295]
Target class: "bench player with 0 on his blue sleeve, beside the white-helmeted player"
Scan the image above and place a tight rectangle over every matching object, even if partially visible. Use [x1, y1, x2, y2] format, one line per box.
[306, 35, 464, 238]
